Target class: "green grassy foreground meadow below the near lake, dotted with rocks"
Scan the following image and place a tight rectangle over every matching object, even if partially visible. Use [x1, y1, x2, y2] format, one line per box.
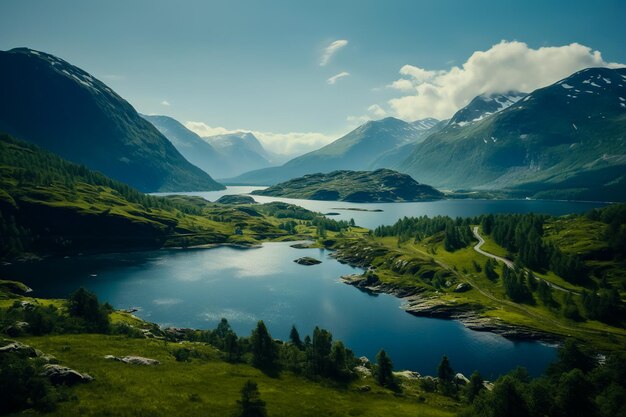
[0, 287, 462, 417]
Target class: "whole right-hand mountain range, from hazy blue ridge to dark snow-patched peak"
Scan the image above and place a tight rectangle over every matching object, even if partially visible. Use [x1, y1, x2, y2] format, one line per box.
[228, 68, 626, 201]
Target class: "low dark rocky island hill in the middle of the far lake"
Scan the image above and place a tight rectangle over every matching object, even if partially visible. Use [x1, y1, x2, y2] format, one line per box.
[252, 169, 444, 203]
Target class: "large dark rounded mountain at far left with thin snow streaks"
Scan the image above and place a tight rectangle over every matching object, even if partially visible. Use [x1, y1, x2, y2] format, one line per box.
[0, 48, 223, 192]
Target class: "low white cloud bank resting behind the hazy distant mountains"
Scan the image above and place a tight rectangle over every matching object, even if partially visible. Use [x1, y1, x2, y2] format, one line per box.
[184, 121, 341, 157]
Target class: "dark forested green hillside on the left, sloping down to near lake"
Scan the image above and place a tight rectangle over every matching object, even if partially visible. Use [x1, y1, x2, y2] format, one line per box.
[0, 135, 332, 258]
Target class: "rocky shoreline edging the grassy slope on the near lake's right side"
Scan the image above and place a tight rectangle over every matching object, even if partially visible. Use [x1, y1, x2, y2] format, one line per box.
[341, 273, 561, 344]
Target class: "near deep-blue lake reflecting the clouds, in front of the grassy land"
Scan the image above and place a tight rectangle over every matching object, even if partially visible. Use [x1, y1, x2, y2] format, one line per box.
[0, 243, 555, 379]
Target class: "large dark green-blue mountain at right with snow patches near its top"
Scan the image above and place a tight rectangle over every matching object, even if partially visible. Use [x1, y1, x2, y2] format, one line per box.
[399, 68, 626, 201]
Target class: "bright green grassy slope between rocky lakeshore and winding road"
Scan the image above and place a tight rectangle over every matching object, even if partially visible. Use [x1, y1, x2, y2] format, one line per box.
[332, 228, 626, 350]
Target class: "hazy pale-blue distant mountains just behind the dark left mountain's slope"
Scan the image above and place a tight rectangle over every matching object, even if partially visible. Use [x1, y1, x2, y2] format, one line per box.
[142, 115, 272, 178]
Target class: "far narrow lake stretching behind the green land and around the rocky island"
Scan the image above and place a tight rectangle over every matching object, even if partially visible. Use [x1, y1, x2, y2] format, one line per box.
[160, 186, 606, 229]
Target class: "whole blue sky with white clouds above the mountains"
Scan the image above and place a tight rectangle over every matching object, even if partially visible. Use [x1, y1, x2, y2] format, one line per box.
[0, 0, 626, 155]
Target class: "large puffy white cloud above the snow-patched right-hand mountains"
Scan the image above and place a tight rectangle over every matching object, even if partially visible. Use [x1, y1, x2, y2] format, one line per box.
[388, 41, 623, 120]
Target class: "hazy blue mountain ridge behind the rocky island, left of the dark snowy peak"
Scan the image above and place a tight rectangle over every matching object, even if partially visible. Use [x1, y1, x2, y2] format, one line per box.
[226, 117, 434, 185]
